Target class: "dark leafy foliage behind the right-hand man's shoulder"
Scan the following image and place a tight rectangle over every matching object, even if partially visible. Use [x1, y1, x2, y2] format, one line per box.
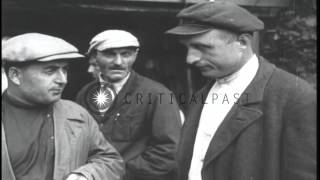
[261, 0, 317, 86]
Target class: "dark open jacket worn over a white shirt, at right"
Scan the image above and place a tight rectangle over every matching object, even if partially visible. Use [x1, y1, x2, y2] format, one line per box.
[178, 58, 316, 180]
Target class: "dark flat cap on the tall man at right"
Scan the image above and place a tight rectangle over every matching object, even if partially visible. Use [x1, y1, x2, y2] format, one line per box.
[166, 1, 264, 35]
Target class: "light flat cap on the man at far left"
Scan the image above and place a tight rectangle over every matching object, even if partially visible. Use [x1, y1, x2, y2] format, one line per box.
[2, 33, 84, 62]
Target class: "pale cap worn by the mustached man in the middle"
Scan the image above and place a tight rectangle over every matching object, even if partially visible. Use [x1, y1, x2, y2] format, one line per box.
[87, 29, 139, 54]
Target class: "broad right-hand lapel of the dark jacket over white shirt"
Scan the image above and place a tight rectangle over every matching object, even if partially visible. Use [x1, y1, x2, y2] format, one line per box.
[203, 58, 274, 169]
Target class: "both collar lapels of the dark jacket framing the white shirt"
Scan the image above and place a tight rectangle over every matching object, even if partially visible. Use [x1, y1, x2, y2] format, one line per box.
[178, 57, 275, 174]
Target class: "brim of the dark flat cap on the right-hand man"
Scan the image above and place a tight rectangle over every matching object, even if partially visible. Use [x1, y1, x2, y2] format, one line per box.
[165, 24, 213, 36]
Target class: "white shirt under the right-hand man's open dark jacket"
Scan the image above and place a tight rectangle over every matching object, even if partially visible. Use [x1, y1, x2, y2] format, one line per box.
[188, 55, 259, 180]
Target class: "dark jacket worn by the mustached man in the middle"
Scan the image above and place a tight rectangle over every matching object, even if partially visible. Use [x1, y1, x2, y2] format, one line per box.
[76, 71, 181, 180]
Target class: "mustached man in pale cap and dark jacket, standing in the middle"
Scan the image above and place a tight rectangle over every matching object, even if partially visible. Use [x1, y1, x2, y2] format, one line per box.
[77, 30, 181, 180]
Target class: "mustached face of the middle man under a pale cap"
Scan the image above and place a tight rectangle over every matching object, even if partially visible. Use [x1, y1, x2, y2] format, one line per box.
[96, 47, 138, 82]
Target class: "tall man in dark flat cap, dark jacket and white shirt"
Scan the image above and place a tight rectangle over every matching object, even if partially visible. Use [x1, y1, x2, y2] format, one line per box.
[166, 1, 316, 180]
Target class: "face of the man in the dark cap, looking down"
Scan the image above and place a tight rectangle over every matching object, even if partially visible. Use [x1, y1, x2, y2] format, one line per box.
[180, 29, 245, 79]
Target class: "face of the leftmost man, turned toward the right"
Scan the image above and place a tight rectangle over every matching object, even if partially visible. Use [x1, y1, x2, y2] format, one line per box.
[18, 61, 68, 104]
